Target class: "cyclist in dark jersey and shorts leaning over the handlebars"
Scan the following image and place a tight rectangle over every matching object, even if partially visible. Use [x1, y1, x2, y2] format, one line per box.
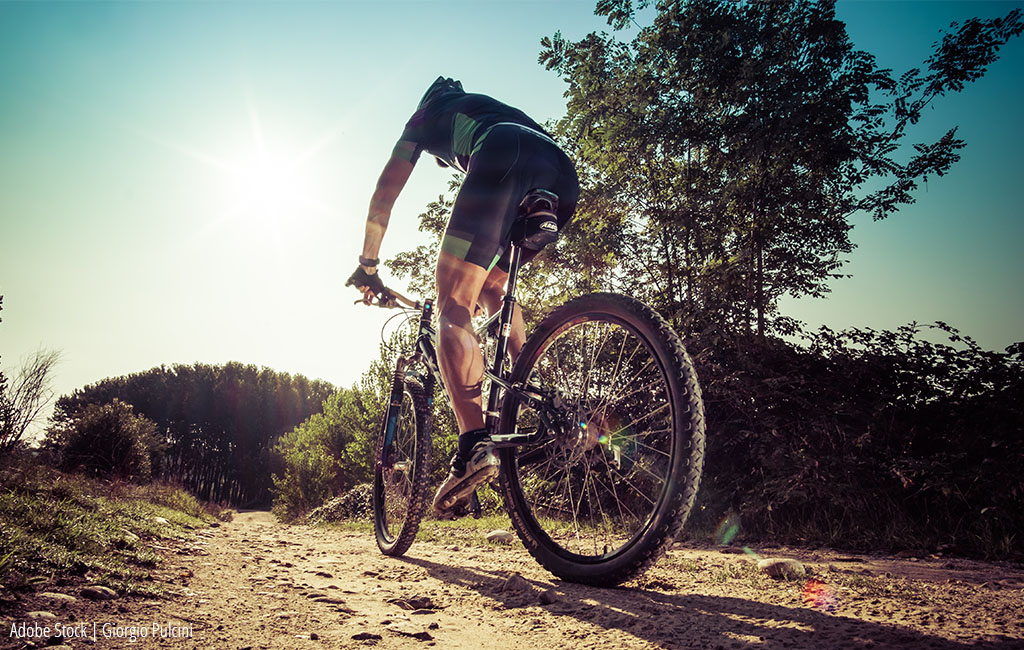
[347, 77, 580, 516]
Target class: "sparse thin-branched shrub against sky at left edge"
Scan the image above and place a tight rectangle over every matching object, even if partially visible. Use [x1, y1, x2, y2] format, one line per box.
[0, 296, 60, 454]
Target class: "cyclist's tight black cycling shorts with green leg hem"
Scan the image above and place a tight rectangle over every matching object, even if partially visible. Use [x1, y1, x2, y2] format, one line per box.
[441, 123, 580, 271]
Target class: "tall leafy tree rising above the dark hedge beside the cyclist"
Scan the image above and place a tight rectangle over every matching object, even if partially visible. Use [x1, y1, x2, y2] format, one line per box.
[540, 0, 1022, 336]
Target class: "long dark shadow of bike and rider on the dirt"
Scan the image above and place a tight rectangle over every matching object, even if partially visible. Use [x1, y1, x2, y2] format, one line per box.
[402, 557, 1020, 650]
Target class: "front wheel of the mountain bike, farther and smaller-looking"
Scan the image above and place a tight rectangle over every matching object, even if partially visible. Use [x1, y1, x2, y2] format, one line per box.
[373, 378, 430, 556]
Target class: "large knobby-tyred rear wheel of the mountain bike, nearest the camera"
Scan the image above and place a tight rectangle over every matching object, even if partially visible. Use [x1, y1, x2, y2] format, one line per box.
[500, 294, 705, 586]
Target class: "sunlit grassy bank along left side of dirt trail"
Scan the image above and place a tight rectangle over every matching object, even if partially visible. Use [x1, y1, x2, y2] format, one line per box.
[0, 464, 213, 594]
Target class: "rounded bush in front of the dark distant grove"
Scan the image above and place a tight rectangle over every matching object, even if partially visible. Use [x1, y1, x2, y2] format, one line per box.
[50, 399, 161, 483]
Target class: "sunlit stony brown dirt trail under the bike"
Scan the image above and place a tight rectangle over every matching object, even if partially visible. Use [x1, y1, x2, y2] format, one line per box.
[9, 512, 1024, 650]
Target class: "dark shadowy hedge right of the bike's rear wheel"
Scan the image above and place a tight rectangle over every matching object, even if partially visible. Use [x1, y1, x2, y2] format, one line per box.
[699, 322, 1024, 557]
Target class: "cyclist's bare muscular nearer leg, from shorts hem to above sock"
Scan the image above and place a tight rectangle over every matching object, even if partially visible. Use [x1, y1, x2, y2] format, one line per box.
[437, 251, 487, 433]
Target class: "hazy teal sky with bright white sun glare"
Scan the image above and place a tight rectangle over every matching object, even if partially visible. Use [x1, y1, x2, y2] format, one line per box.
[0, 0, 1024, 429]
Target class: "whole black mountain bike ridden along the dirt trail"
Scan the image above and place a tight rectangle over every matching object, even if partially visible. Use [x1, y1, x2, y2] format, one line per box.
[364, 190, 705, 586]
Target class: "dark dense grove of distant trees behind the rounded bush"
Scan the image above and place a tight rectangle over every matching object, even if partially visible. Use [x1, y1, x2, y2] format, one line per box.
[48, 362, 335, 505]
